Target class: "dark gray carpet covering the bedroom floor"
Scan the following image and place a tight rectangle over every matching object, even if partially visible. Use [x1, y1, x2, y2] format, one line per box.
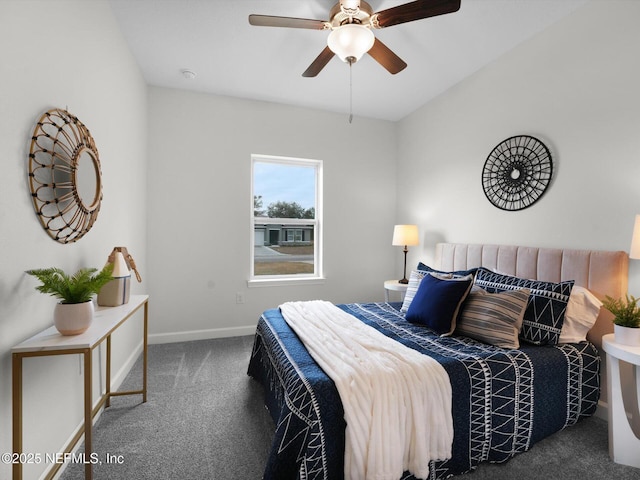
[61, 336, 640, 480]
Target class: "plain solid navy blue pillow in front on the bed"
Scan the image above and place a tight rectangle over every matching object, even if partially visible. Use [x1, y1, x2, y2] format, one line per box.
[405, 275, 473, 335]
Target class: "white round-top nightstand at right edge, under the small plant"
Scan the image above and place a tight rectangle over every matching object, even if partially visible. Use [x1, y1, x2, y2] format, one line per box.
[602, 333, 640, 468]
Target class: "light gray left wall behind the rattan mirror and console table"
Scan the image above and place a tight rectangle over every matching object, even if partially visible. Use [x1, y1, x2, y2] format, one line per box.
[0, 0, 148, 479]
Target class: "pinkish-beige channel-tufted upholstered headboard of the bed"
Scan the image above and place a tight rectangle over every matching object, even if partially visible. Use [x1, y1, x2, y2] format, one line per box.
[435, 243, 629, 348]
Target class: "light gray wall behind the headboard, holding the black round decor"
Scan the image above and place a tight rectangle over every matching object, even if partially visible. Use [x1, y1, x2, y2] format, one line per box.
[397, 1, 640, 295]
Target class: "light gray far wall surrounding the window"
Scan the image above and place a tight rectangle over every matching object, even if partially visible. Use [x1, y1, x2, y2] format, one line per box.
[148, 87, 401, 342]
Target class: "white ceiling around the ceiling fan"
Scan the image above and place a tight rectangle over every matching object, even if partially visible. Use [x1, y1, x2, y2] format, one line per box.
[110, 0, 587, 121]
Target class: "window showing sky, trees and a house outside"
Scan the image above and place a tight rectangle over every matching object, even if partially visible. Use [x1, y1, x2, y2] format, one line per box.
[249, 155, 322, 285]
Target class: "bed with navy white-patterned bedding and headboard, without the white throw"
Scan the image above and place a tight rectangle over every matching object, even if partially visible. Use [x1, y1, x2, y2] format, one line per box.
[248, 243, 628, 480]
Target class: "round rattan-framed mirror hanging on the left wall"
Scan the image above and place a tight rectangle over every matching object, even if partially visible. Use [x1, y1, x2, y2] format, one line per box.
[29, 109, 102, 243]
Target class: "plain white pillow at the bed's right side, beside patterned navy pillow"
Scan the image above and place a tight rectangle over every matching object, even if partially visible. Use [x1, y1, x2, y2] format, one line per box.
[558, 285, 602, 343]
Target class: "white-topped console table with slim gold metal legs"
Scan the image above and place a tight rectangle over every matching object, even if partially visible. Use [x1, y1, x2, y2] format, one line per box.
[11, 295, 149, 480]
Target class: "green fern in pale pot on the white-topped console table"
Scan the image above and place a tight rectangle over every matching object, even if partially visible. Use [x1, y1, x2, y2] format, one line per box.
[26, 264, 113, 335]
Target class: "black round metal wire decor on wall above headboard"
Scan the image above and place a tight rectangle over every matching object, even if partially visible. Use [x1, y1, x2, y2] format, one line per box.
[482, 135, 553, 211]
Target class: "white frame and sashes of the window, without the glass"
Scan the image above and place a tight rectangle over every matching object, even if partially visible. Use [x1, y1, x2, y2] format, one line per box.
[247, 154, 324, 287]
